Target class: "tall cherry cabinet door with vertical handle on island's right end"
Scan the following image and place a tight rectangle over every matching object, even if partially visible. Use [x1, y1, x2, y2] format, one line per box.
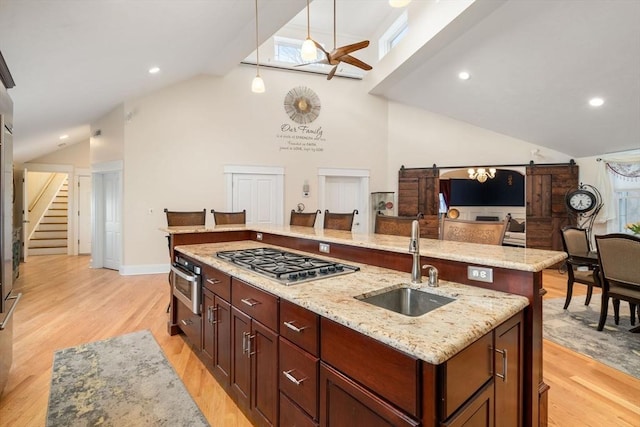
[494, 313, 523, 427]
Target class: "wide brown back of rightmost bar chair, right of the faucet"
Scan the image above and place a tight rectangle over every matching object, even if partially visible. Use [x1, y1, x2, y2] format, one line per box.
[440, 217, 509, 245]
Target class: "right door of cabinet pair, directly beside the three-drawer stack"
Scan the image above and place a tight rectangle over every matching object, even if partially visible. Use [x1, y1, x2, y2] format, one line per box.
[249, 319, 278, 425]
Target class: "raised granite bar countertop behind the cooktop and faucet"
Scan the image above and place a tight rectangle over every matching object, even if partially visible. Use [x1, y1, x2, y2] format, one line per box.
[161, 225, 567, 272]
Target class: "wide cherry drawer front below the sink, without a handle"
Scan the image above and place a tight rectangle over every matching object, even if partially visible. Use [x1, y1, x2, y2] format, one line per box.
[320, 317, 420, 417]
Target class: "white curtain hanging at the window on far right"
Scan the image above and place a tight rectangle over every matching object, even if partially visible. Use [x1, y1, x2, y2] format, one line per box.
[596, 153, 640, 222]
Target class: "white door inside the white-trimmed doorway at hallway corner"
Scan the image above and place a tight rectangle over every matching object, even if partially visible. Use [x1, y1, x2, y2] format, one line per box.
[103, 172, 122, 270]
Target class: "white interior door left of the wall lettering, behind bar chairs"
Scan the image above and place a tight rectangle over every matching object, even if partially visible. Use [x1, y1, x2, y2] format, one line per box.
[232, 174, 282, 225]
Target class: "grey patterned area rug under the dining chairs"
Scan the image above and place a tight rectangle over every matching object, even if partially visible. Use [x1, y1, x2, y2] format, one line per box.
[542, 295, 640, 379]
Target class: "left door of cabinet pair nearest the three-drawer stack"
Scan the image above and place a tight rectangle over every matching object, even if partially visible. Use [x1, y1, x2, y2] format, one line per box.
[231, 307, 251, 413]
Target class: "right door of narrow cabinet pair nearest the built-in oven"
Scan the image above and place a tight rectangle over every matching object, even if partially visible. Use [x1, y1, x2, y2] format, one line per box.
[212, 295, 231, 387]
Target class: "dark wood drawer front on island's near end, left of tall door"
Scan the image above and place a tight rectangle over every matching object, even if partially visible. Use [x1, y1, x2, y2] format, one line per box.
[441, 332, 493, 418]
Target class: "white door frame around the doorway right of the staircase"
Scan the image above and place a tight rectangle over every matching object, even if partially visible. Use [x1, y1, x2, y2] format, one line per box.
[91, 160, 124, 272]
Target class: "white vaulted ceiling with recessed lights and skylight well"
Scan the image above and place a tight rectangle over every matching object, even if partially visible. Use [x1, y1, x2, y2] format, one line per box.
[0, 0, 640, 161]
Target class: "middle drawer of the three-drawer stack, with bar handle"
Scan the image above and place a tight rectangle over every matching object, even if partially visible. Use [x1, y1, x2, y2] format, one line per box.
[280, 337, 319, 419]
